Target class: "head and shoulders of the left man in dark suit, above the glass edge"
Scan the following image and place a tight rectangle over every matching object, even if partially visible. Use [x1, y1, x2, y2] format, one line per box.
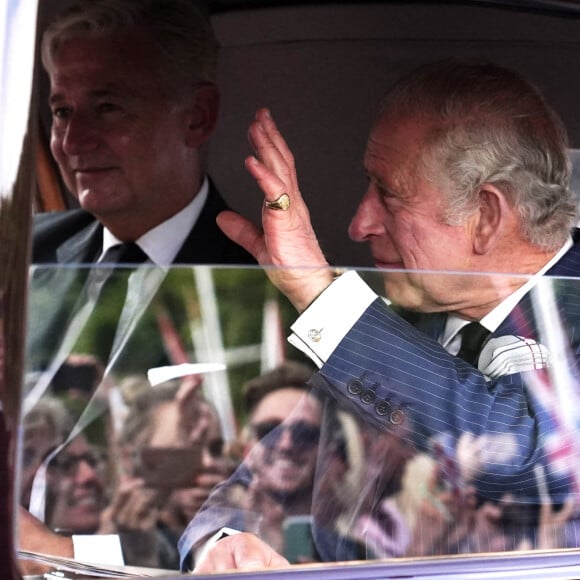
[32, 0, 253, 265]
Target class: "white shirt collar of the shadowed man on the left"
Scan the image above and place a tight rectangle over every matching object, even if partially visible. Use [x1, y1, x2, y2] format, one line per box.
[98, 177, 209, 266]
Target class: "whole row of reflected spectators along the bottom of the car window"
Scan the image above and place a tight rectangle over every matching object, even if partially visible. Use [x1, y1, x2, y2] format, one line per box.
[20, 358, 578, 570]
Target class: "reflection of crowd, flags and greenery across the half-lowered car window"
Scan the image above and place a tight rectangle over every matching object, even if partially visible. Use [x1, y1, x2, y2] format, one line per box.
[21, 267, 579, 570]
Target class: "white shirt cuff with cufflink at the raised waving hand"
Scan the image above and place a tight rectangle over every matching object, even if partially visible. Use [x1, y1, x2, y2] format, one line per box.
[288, 271, 377, 368]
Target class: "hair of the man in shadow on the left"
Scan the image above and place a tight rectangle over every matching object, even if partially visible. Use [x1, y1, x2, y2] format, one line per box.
[41, 0, 219, 90]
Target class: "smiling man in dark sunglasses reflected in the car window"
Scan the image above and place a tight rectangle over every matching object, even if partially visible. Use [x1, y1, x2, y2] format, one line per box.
[182, 361, 357, 563]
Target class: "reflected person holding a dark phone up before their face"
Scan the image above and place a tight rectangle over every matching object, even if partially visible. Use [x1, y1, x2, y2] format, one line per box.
[99, 377, 235, 570]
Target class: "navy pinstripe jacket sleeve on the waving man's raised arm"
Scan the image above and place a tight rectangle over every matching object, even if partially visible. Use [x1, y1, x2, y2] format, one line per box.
[312, 299, 569, 502]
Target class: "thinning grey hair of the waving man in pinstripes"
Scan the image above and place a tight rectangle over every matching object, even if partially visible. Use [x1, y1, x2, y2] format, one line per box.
[381, 59, 576, 250]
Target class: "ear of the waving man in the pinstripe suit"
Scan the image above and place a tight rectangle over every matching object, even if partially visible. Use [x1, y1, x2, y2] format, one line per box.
[473, 183, 510, 254]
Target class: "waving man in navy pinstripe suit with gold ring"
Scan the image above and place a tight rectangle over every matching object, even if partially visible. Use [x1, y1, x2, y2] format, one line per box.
[185, 61, 580, 572]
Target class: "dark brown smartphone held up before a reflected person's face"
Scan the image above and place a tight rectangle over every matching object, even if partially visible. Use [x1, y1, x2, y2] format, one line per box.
[137, 444, 203, 488]
